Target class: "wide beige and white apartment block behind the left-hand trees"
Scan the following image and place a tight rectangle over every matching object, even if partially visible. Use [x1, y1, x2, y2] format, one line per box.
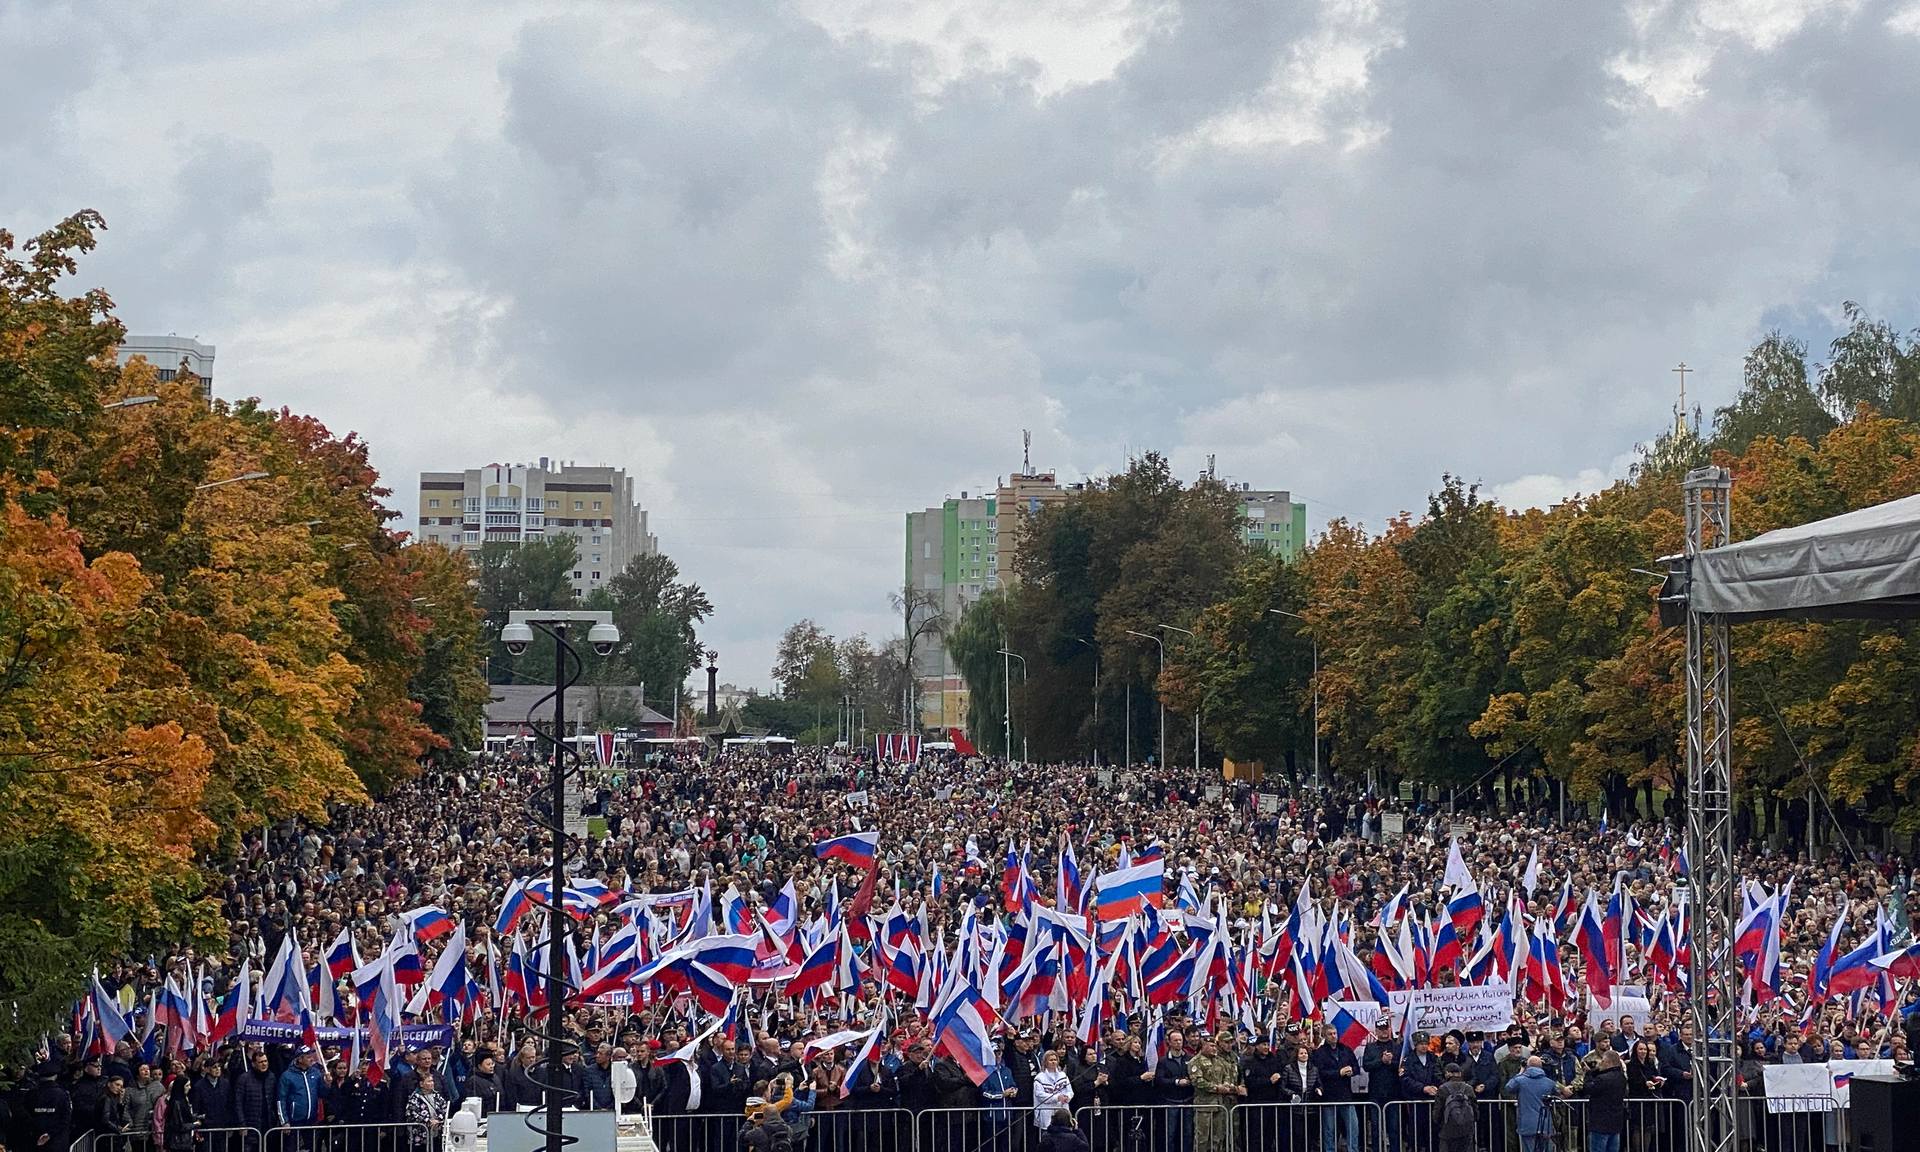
[415, 457, 659, 595]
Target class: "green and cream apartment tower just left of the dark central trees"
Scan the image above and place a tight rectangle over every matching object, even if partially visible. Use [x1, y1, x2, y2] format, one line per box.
[904, 492, 1000, 728]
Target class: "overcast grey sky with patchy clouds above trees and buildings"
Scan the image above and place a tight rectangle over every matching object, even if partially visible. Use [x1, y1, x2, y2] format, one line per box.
[0, 0, 1920, 684]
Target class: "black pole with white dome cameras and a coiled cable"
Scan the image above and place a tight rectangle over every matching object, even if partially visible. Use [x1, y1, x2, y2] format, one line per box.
[499, 609, 620, 1152]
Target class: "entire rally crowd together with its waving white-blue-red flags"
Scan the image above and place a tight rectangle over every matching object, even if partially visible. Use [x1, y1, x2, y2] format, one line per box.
[6, 749, 1920, 1150]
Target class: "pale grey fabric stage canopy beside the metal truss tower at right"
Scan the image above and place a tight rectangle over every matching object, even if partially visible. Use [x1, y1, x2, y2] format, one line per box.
[1661, 495, 1920, 622]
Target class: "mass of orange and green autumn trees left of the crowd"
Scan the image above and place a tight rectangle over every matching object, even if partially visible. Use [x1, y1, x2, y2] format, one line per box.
[0, 213, 486, 1054]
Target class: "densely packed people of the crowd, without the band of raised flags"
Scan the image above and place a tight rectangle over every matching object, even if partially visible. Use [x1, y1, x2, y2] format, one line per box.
[0, 751, 1916, 1152]
